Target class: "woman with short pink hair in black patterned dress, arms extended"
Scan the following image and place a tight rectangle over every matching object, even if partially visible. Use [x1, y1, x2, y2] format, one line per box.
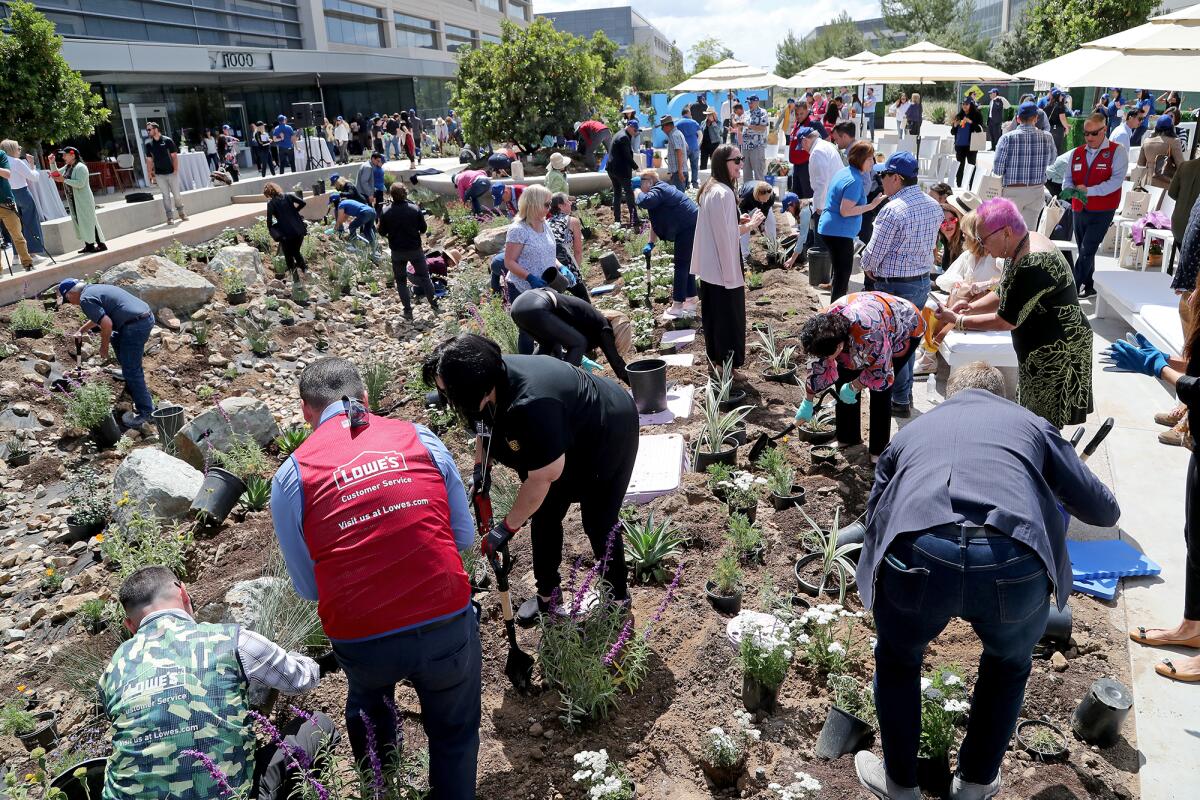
[937, 198, 1093, 428]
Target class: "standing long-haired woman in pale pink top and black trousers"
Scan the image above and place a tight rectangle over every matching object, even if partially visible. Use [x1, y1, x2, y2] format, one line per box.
[691, 144, 763, 380]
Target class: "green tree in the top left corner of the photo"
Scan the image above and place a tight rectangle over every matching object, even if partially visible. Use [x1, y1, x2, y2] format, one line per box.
[0, 0, 109, 148]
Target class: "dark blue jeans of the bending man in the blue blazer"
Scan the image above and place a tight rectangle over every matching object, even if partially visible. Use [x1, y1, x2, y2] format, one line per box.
[874, 527, 1051, 787]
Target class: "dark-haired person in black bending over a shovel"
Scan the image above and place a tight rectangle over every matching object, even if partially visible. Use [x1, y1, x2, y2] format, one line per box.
[422, 333, 638, 626]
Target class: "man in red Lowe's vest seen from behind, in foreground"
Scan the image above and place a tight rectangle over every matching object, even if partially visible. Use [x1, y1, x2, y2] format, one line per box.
[271, 359, 480, 800]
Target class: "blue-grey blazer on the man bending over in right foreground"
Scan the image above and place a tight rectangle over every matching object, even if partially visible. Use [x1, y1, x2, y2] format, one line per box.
[857, 389, 1121, 609]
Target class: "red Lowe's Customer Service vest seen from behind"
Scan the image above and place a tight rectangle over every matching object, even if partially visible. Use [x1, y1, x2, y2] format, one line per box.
[293, 415, 470, 640]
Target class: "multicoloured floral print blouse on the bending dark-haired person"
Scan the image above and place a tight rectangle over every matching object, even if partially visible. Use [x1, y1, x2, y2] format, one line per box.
[808, 291, 925, 395]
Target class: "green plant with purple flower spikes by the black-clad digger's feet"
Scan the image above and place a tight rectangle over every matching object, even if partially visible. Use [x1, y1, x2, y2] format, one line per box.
[538, 525, 683, 730]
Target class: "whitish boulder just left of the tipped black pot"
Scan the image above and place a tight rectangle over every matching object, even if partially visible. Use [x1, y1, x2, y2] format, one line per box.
[113, 447, 204, 522]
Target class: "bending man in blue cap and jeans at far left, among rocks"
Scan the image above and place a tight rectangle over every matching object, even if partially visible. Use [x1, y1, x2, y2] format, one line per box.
[59, 278, 154, 428]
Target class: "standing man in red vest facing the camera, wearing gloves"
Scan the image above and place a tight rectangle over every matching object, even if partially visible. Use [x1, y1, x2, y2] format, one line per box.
[1062, 113, 1129, 297]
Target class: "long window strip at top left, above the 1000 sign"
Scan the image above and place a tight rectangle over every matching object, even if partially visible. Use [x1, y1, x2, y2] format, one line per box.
[18, 0, 301, 48]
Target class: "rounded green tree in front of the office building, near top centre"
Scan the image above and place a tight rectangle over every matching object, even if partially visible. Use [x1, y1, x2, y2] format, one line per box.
[451, 18, 624, 145]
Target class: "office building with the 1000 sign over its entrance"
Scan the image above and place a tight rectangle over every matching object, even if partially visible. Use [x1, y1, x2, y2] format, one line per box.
[9, 0, 532, 156]
